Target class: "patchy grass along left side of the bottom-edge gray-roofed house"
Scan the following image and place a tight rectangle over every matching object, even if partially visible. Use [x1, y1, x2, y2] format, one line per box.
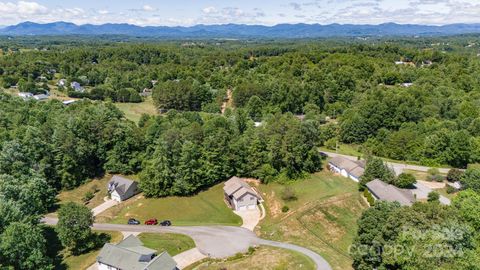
[45, 226, 123, 270]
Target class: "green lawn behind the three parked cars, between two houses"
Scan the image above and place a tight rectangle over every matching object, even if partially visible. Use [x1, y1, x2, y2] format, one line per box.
[96, 184, 242, 226]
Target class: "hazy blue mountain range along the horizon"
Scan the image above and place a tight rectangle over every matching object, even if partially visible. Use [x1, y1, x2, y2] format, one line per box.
[0, 22, 480, 38]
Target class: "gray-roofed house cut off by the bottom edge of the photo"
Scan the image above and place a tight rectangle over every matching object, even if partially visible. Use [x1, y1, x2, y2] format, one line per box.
[97, 235, 178, 270]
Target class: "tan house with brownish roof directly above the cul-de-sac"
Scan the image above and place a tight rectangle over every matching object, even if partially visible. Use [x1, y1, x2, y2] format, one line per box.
[223, 176, 261, 211]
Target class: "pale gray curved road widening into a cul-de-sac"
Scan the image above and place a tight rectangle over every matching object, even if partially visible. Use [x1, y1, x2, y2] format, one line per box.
[42, 217, 332, 270]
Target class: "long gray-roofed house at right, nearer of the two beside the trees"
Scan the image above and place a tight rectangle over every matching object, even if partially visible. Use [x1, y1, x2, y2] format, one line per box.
[366, 179, 416, 206]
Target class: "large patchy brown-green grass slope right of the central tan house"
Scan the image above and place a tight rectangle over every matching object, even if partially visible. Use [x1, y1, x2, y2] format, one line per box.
[257, 170, 367, 270]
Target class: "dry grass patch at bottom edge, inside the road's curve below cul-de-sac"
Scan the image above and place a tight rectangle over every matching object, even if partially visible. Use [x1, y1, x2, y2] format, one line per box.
[185, 246, 315, 270]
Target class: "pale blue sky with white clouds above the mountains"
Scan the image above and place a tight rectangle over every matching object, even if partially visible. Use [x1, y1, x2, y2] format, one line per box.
[0, 0, 480, 26]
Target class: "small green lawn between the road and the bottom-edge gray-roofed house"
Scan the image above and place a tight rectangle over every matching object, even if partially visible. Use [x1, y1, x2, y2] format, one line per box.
[138, 233, 195, 256]
